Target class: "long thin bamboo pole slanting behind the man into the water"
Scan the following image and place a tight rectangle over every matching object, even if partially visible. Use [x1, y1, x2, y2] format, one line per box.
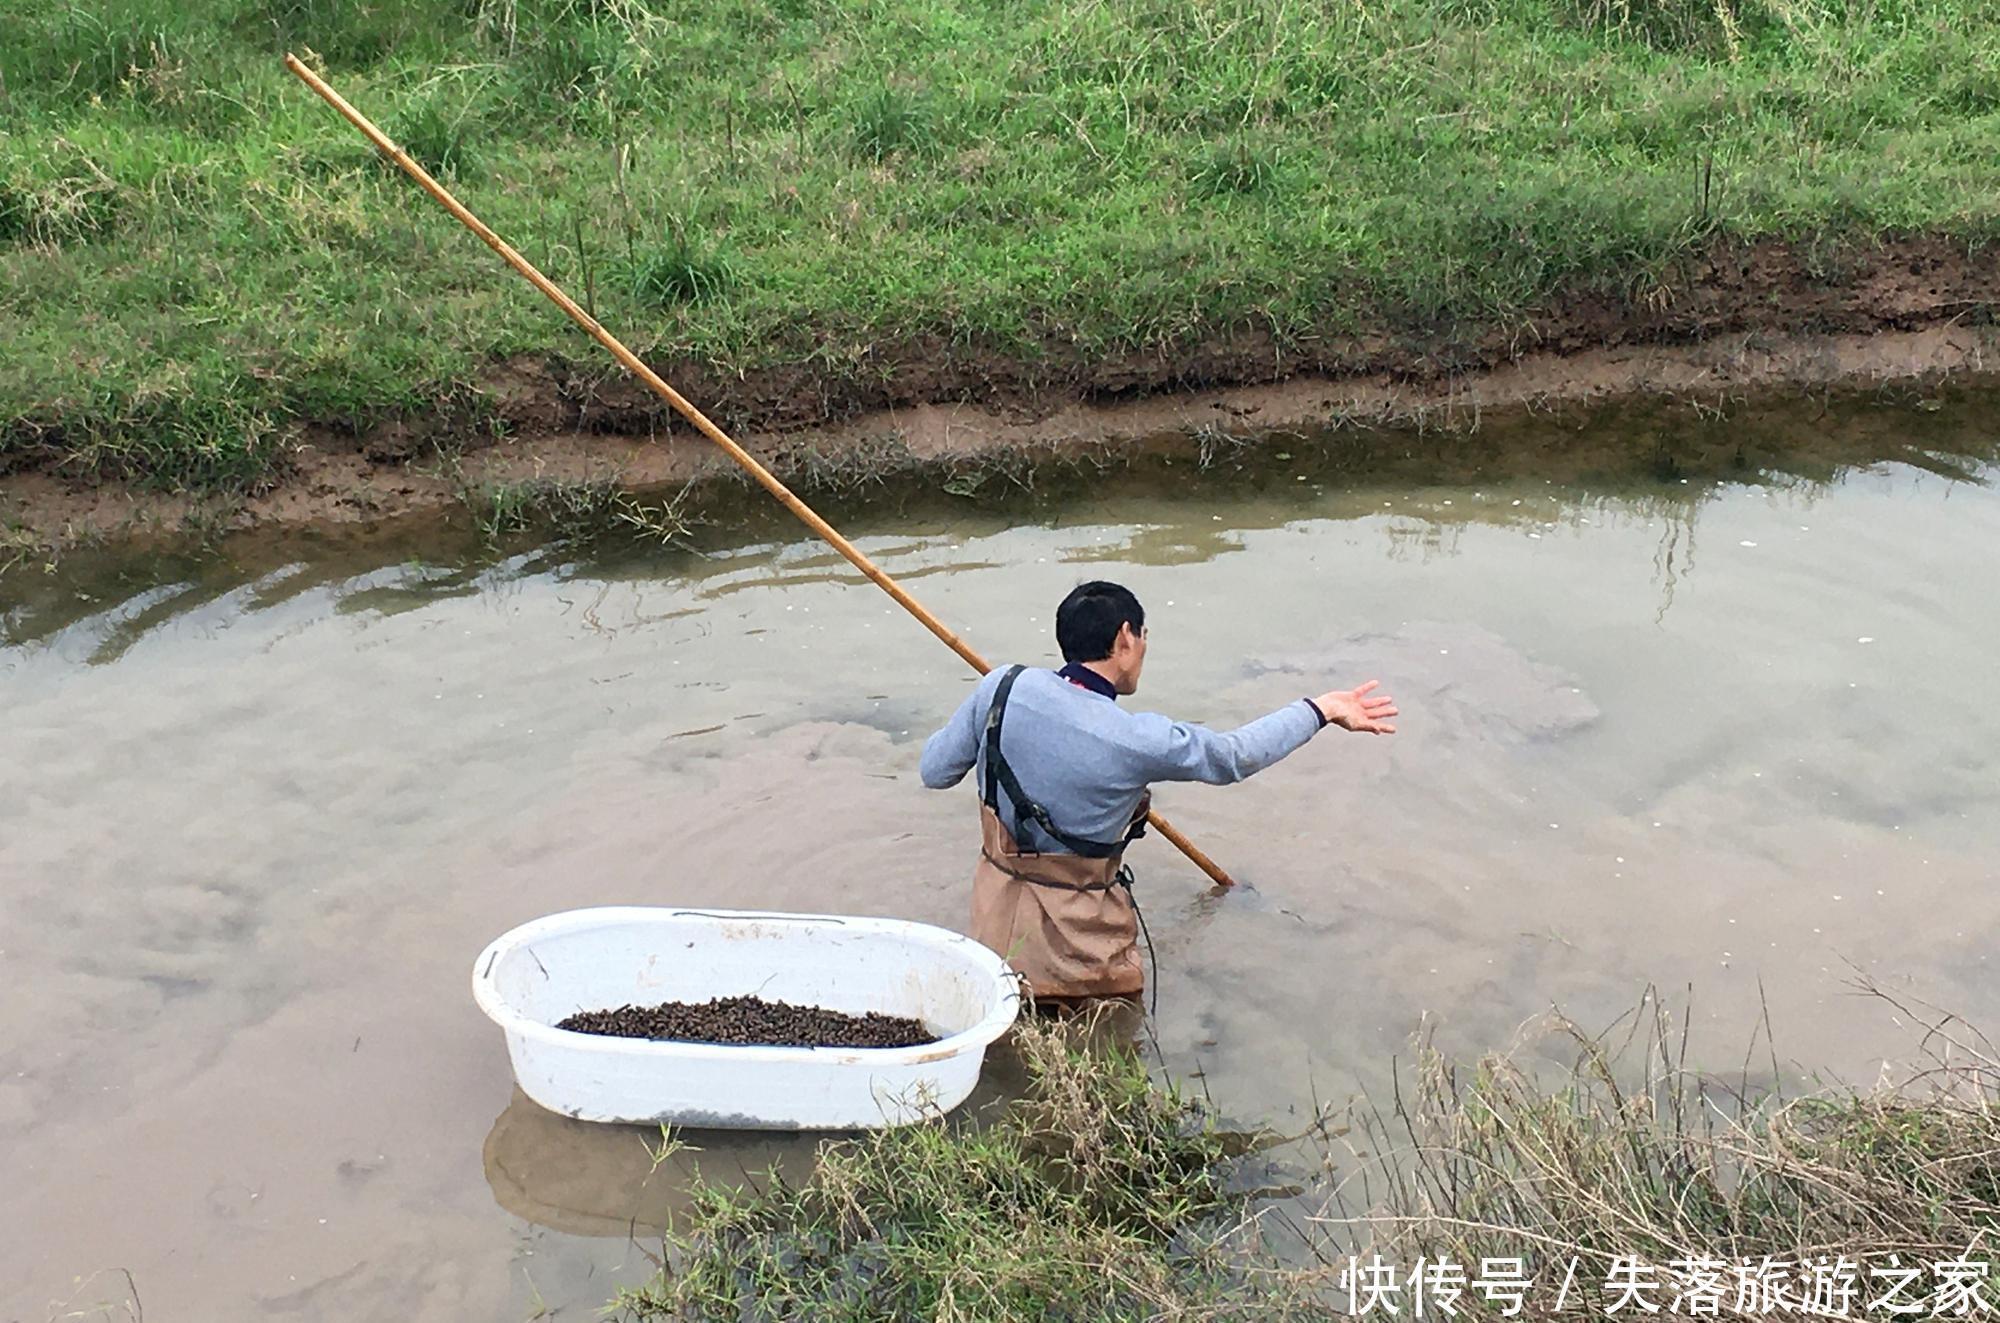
[284, 54, 1236, 887]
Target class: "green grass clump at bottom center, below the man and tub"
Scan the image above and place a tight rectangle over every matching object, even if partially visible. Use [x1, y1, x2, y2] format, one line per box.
[618, 1023, 1242, 1323]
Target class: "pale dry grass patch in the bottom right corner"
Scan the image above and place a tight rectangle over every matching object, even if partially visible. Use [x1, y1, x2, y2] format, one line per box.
[1316, 983, 2000, 1317]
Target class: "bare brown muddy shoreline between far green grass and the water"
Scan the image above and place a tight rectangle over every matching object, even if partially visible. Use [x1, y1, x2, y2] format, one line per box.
[0, 259, 2000, 562]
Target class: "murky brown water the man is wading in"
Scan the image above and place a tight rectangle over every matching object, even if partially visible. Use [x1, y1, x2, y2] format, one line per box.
[0, 403, 2000, 1323]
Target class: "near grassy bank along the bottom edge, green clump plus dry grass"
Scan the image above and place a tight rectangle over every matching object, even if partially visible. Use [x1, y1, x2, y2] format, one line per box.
[618, 1007, 2000, 1323]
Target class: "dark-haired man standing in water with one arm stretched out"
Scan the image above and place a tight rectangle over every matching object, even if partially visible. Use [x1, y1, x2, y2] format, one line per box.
[922, 582, 1396, 999]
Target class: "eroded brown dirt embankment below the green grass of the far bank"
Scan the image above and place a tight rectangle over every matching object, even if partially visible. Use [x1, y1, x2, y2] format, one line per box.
[0, 238, 2000, 542]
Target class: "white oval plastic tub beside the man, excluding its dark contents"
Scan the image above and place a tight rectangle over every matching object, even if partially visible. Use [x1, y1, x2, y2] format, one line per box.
[472, 905, 1020, 1129]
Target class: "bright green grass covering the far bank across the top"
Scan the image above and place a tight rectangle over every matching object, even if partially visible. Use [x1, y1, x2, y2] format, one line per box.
[0, 0, 2000, 486]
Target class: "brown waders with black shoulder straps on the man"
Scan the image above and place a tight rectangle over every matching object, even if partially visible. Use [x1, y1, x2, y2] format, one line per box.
[972, 665, 1150, 999]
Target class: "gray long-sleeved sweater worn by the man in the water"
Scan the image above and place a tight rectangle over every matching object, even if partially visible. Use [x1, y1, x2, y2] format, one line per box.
[922, 667, 1320, 853]
